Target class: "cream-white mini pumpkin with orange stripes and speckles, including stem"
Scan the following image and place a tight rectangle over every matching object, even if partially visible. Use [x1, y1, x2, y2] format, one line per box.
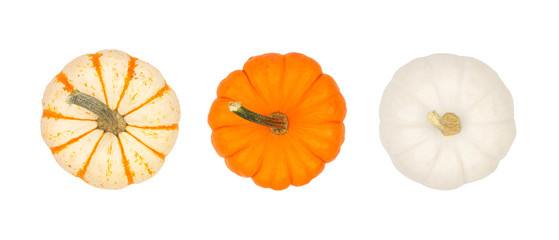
[41, 50, 180, 189]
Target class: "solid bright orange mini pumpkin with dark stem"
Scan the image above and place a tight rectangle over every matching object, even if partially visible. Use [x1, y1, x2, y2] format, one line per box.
[208, 53, 346, 190]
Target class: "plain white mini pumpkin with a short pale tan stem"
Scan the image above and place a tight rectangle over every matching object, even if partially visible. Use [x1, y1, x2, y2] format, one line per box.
[380, 54, 516, 189]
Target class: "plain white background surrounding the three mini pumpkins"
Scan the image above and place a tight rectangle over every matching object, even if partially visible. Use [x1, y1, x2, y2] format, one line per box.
[0, 0, 559, 239]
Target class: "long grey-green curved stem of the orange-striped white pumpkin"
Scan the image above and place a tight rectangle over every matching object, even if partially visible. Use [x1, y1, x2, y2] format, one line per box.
[66, 90, 126, 136]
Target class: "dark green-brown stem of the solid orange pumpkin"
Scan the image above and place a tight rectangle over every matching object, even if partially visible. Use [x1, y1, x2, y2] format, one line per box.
[229, 102, 288, 135]
